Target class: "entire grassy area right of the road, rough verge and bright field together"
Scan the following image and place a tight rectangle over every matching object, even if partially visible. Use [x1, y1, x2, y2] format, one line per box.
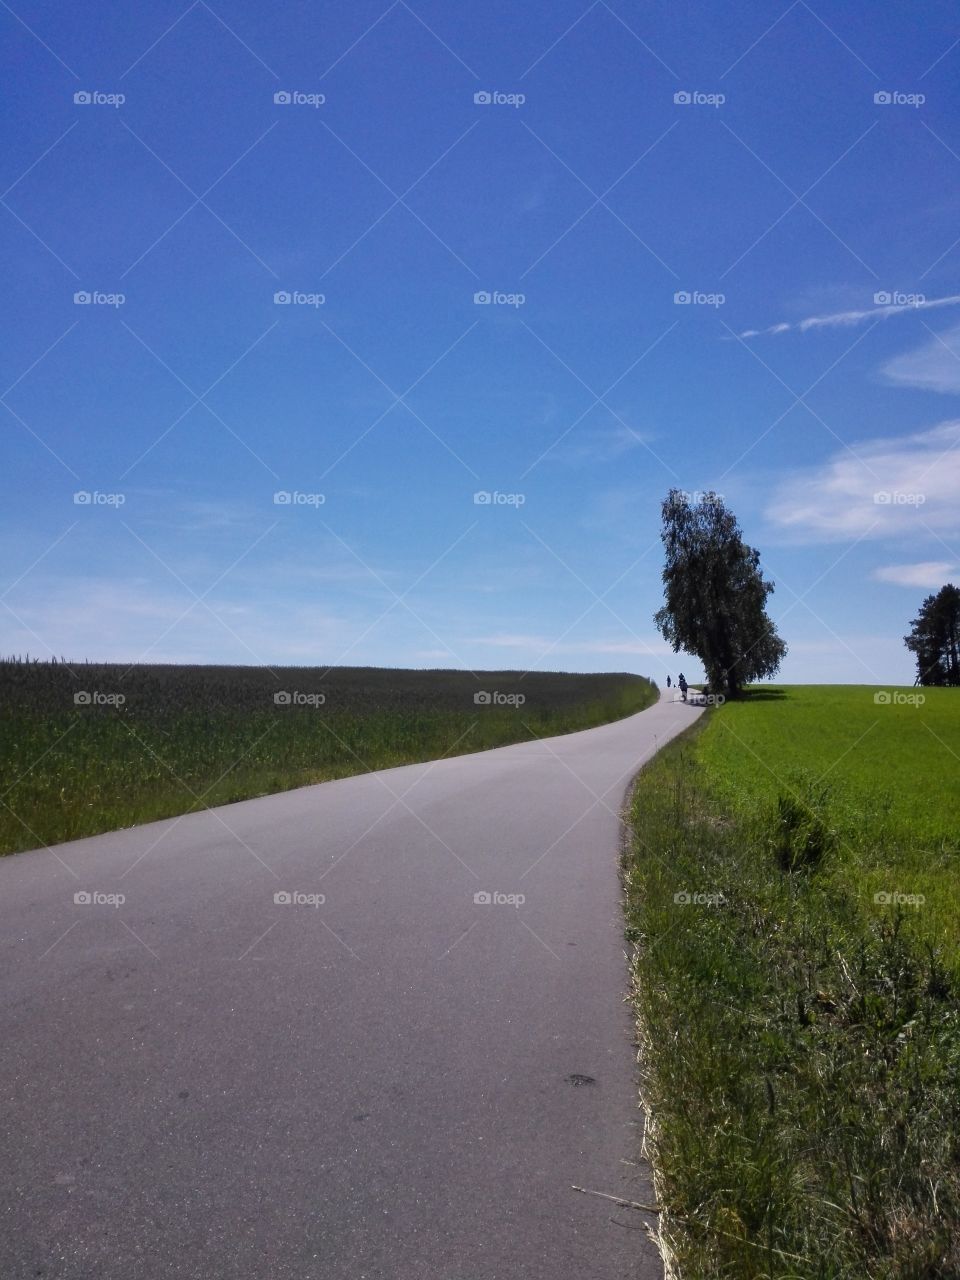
[625, 689, 960, 1280]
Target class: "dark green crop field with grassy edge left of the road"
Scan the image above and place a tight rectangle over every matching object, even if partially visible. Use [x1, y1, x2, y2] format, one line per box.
[0, 662, 657, 852]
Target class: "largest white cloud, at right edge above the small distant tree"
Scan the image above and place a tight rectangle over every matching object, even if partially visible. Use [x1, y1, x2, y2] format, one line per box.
[765, 421, 960, 541]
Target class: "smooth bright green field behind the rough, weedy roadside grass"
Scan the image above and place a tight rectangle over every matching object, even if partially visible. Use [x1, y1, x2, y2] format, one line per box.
[699, 685, 960, 964]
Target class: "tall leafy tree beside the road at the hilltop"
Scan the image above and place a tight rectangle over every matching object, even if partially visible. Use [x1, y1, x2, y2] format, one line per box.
[654, 489, 787, 696]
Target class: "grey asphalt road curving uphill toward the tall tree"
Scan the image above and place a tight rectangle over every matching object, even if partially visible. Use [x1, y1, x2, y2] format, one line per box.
[0, 698, 700, 1280]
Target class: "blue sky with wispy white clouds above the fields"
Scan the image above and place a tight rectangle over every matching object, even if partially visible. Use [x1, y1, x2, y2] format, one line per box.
[0, 0, 960, 684]
